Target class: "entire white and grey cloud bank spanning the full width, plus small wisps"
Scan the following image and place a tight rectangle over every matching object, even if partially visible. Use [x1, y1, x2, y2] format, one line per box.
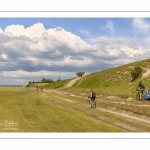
[0, 20, 150, 84]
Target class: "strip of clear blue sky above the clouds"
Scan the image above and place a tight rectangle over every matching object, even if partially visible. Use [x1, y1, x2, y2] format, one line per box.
[0, 18, 134, 38]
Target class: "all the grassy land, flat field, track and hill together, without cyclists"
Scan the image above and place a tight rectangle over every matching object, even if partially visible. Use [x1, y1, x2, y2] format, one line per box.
[0, 59, 150, 132]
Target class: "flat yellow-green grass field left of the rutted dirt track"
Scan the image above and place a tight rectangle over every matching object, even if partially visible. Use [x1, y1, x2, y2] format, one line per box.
[0, 87, 125, 132]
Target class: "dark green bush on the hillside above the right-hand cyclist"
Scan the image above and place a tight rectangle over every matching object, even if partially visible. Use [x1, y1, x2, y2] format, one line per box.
[131, 67, 142, 82]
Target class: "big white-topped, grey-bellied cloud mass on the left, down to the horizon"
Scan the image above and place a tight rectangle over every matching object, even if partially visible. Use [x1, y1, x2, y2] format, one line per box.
[0, 23, 97, 83]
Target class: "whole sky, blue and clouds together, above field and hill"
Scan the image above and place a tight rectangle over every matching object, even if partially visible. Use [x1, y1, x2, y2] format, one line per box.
[0, 17, 150, 85]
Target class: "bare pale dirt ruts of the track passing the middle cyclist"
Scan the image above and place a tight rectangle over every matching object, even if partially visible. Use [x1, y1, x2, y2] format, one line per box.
[42, 90, 150, 131]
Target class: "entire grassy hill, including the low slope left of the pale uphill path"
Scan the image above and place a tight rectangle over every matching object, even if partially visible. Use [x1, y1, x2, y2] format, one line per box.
[39, 59, 150, 99]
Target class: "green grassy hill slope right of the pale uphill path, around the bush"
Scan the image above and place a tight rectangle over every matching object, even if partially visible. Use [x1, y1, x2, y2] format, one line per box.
[74, 59, 150, 95]
